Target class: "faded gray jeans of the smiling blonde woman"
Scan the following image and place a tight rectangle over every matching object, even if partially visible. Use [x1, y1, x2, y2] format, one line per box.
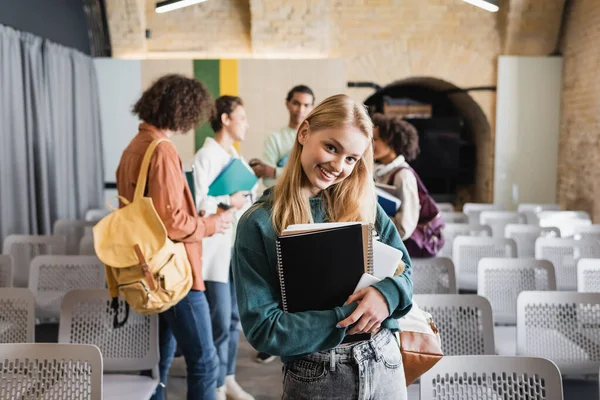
[282, 329, 407, 400]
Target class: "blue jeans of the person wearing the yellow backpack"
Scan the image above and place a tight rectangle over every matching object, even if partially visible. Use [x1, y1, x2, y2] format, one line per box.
[152, 290, 219, 400]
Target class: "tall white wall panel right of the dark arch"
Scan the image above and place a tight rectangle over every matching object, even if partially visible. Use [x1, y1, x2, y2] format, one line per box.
[494, 56, 563, 209]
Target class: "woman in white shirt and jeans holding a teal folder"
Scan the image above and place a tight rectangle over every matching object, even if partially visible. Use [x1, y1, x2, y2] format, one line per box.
[194, 96, 258, 400]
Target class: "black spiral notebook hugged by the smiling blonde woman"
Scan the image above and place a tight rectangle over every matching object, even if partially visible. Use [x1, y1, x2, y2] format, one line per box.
[277, 223, 373, 342]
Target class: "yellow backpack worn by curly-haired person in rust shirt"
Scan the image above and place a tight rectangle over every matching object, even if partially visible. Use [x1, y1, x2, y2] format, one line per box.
[93, 139, 193, 327]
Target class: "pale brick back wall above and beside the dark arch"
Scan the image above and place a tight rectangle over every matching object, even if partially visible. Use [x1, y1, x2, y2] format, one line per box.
[107, 0, 572, 201]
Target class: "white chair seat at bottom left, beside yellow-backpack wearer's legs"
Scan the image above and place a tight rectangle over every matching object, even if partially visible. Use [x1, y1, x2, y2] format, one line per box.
[102, 374, 158, 400]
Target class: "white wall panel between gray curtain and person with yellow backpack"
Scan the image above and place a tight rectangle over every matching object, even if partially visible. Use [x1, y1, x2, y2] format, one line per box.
[94, 58, 142, 205]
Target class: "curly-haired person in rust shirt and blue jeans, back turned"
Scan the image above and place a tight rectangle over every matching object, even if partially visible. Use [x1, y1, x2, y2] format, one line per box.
[117, 75, 232, 400]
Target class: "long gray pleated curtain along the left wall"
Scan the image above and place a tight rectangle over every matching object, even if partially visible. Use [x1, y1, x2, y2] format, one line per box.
[0, 25, 104, 244]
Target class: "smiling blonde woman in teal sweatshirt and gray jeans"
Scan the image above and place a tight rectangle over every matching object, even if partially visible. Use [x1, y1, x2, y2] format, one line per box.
[233, 95, 412, 400]
